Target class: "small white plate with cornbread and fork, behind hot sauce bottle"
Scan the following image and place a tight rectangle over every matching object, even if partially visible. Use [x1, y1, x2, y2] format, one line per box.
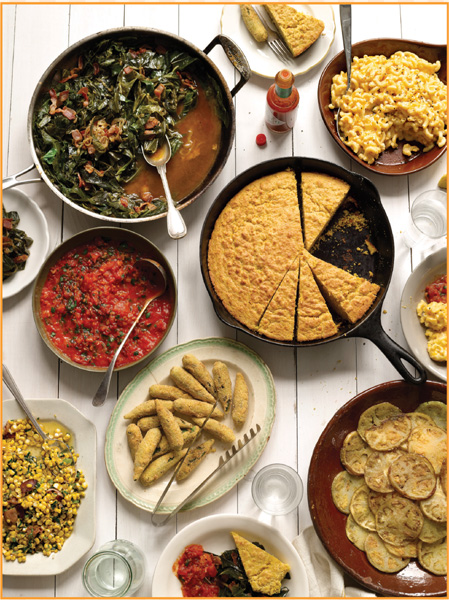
[221, 4, 335, 78]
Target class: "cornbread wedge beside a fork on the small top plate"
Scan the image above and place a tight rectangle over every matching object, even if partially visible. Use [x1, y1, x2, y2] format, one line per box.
[264, 4, 324, 56]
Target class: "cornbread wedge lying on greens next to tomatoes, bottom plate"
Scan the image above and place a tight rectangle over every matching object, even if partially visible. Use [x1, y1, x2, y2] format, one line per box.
[231, 531, 290, 596]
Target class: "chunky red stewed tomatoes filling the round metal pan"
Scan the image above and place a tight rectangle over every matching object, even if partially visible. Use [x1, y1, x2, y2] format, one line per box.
[40, 237, 173, 367]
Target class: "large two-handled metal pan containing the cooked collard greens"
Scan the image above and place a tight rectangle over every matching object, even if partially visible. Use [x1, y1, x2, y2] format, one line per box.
[3, 27, 251, 223]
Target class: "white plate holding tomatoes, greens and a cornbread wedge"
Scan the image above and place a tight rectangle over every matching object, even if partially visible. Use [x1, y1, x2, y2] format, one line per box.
[151, 515, 309, 598]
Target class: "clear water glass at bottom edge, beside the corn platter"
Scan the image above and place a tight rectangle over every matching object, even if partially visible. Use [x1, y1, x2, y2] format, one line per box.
[83, 540, 145, 598]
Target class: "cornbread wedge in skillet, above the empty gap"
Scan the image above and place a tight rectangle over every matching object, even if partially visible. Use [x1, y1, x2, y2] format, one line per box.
[301, 173, 350, 250]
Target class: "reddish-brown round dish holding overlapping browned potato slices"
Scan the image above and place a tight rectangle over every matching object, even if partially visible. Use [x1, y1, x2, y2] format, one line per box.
[308, 381, 447, 596]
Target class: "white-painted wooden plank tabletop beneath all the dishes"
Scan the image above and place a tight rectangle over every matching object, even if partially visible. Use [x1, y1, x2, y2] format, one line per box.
[2, 2, 447, 598]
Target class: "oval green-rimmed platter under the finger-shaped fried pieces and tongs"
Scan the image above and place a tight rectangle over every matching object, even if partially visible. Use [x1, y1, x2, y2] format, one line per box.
[105, 338, 276, 513]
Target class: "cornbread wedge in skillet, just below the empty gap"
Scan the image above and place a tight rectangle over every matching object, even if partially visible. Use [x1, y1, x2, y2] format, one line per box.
[304, 250, 380, 323]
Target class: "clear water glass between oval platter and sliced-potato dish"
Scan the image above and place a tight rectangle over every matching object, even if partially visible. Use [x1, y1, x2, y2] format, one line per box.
[251, 464, 303, 515]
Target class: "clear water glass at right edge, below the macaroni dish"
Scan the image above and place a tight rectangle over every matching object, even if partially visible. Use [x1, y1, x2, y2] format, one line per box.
[403, 189, 447, 248]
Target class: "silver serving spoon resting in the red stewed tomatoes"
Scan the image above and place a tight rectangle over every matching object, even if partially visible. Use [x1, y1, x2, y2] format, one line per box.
[92, 258, 167, 406]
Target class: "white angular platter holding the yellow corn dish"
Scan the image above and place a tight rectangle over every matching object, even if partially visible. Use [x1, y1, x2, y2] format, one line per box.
[3, 398, 97, 577]
